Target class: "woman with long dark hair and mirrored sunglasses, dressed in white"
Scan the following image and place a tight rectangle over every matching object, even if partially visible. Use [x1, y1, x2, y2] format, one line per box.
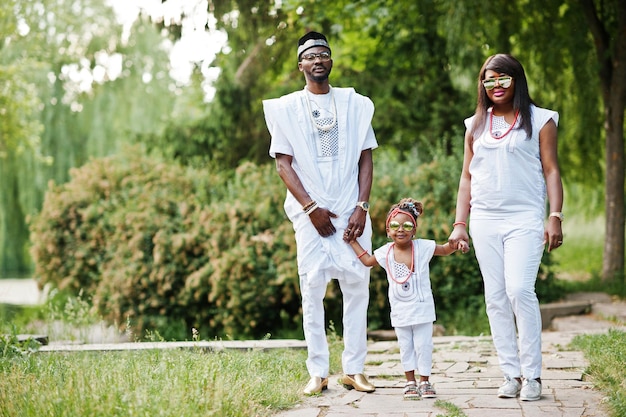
[449, 54, 563, 401]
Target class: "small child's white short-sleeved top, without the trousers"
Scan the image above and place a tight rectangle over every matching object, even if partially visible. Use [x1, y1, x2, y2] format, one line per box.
[374, 239, 436, 327]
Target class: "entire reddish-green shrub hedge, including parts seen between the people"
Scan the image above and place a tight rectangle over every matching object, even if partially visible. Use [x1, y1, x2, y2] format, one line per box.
[30, 148, 558, 339]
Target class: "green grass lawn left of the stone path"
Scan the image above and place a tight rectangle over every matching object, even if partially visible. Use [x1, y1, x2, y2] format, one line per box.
[0, 349, 312, 417]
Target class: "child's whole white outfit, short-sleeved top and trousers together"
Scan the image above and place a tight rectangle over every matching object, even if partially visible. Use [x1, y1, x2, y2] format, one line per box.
[374, 239, 437, 376]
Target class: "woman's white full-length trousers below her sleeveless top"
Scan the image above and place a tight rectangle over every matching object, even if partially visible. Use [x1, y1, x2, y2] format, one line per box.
[470, 217, 544, 379]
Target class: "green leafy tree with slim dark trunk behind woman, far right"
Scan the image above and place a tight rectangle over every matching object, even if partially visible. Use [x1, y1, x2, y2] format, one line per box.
[438, 0, 626, 280]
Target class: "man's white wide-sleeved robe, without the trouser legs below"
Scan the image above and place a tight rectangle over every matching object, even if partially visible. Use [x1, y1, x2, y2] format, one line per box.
[263, 88, 378, 285]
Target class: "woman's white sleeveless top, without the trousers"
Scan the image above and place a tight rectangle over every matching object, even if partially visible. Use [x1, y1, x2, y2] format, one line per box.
[465, 105, 559, 219]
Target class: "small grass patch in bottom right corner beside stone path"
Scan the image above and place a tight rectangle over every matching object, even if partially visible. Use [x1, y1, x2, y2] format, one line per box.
[572, 329, 626, 417]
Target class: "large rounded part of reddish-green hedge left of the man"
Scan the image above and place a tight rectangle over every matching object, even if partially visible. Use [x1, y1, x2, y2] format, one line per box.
[31, 150, 299, 337]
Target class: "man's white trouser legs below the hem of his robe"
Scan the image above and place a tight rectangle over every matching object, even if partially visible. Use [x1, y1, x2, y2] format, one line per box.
[300, 275, 369, 378]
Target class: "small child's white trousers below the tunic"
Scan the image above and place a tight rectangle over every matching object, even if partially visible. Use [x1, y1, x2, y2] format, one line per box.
[395, 322, 433, 376]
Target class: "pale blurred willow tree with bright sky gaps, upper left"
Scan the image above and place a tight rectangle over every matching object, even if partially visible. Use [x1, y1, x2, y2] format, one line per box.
[0, 0, 177, 275]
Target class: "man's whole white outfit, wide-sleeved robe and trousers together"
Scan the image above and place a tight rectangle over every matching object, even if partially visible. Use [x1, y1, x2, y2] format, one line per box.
[263, 88, 378, 378]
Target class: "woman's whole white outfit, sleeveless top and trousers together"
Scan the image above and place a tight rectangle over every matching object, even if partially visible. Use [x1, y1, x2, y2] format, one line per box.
[465, 105, 559, 380]
